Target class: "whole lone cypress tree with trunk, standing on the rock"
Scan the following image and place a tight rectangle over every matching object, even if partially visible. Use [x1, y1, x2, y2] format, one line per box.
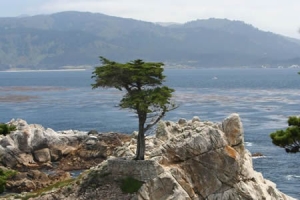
[92, 57, 176, 160]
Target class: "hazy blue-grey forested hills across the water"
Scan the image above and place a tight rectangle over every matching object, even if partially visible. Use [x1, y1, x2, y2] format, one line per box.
[0, 12, 300, 70]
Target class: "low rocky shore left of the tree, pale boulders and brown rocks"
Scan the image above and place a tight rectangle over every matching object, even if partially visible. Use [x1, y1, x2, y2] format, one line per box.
[0, 119, 131, 192]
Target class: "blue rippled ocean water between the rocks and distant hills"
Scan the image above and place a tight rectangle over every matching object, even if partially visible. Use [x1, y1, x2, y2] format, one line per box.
[0, 69, 300, 198]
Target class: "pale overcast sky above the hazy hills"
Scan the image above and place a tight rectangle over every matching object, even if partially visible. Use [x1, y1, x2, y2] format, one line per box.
[0, 0, 300, 39]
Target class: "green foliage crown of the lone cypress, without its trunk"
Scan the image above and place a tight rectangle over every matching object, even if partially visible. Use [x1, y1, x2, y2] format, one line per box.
[92, 57, 174, 117]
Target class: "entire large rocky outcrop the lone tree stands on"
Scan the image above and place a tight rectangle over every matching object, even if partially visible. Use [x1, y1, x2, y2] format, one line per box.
[13, 114, 293, 200]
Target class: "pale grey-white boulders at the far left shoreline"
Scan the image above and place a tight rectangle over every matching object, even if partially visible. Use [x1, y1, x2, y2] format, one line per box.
[0, 119, 88, 168]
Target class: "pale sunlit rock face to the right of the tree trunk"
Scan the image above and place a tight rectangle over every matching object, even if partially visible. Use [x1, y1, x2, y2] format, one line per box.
[137, 114, 292, 200]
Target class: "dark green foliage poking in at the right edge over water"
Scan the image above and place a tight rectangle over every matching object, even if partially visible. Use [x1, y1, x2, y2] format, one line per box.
[270, 116, 300, 153]
